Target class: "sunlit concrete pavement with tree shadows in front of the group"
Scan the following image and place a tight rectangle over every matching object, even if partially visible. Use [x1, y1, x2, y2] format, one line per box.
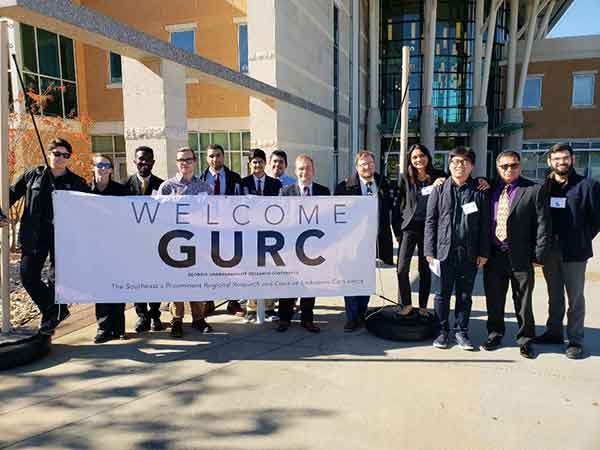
[0, 263, 600, 450]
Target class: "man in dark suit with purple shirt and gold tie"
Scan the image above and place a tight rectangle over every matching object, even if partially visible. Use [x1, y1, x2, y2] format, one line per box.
[483, 150, 550, 358]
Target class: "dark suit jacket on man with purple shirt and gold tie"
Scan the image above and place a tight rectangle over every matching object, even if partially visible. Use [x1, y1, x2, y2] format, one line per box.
[490, 178, 552, 271]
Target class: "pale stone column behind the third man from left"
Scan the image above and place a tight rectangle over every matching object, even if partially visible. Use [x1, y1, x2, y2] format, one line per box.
[122, 57, 188, 178]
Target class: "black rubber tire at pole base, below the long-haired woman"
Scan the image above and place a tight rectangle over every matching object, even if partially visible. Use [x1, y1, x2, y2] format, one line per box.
[366, 306, 438, 341]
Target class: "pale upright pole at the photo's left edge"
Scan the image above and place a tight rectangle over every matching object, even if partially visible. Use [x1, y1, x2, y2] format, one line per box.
[0, 21, 11, 333]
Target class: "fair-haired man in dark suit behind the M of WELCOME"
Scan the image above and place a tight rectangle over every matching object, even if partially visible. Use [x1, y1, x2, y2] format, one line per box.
[277, 155, 331, 333]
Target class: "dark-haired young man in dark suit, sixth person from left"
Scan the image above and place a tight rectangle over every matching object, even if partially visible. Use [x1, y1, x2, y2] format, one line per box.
[240, 148, 282, 323]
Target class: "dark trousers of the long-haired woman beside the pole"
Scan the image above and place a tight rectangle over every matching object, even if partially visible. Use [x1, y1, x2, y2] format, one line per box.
[398, 223, 431, 308]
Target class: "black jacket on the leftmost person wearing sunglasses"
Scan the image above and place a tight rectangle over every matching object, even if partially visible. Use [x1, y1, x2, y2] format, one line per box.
[9, 166, 90, 252]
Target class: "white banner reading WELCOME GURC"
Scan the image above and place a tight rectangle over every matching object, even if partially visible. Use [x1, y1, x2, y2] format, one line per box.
[53, 191, 377, 303]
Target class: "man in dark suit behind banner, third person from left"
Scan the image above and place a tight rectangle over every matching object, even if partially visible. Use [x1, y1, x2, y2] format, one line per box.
[125, 146, 164, 333]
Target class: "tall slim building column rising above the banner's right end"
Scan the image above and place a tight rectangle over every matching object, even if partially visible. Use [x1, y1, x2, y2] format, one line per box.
[367, 0, 381, 170]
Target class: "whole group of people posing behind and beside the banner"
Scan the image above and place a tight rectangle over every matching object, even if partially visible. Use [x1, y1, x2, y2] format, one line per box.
[5, 135, 600, 358]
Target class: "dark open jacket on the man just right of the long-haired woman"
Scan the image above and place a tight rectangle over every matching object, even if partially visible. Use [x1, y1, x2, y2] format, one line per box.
[424, 178, 491, 262]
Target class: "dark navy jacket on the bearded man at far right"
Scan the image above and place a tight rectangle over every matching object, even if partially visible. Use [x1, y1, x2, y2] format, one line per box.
[544, 171, 600, 262]
